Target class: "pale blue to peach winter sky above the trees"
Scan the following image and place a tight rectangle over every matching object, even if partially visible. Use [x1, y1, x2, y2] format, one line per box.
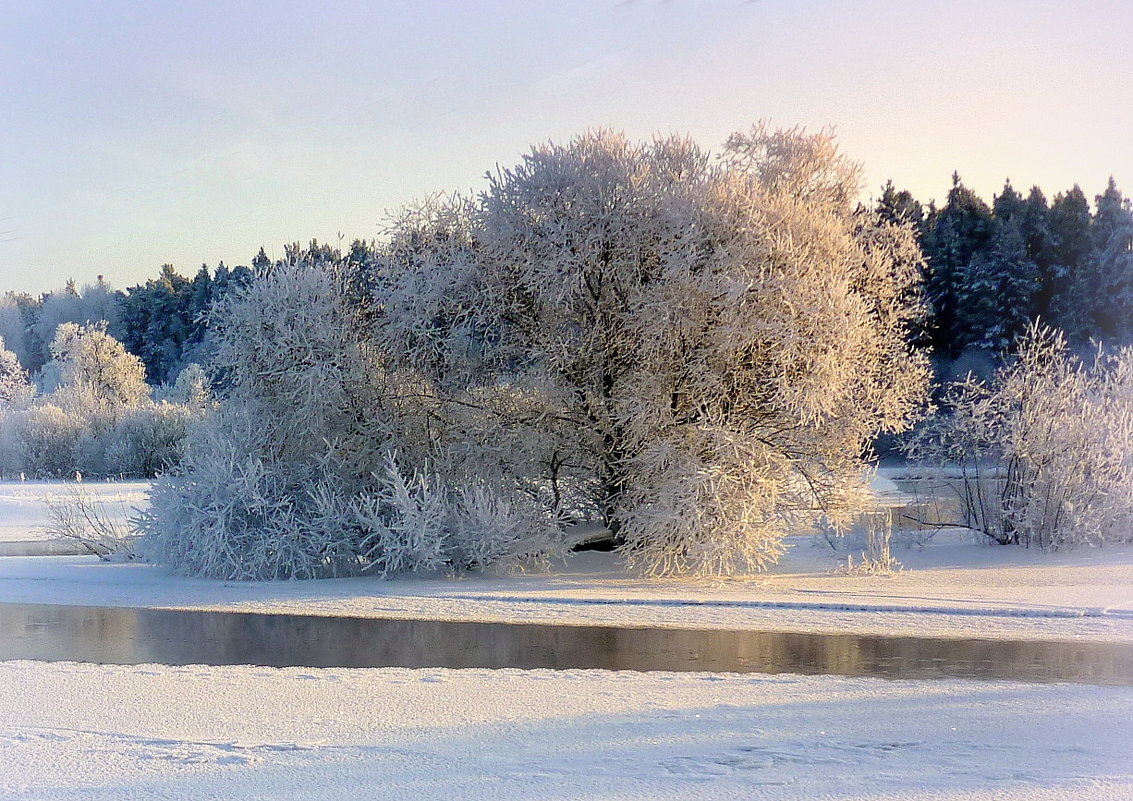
[0, 0, 1133, 293]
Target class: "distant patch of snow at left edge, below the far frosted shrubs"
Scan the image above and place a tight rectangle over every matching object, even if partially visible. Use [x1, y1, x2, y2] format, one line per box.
[0, 482, 150, 542]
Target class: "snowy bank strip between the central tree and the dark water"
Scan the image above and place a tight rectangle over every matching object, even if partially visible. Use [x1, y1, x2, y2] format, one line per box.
[0, 534, 1133, 641]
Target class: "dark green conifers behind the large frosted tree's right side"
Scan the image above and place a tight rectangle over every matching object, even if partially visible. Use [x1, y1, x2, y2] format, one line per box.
[876, 173, 1133, 360]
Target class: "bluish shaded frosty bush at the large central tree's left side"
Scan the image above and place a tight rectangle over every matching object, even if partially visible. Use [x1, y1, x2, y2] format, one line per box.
[136, 259, 561, 580]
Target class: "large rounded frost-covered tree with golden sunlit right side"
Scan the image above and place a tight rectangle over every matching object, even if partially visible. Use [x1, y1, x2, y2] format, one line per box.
[376, 127, 927, 573]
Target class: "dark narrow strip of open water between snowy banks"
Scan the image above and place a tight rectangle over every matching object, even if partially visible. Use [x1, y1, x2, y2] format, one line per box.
[0, 604, 1133, 684]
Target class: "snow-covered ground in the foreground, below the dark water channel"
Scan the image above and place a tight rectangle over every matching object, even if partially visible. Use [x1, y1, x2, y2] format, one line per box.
[0, 662, 1133, 801]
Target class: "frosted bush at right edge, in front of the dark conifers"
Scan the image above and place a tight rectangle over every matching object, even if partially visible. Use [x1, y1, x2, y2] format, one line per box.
[909, 326, 1133, 547]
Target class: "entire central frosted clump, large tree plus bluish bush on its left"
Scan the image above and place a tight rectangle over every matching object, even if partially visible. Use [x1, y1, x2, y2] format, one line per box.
[142, 128, 928, 578]
